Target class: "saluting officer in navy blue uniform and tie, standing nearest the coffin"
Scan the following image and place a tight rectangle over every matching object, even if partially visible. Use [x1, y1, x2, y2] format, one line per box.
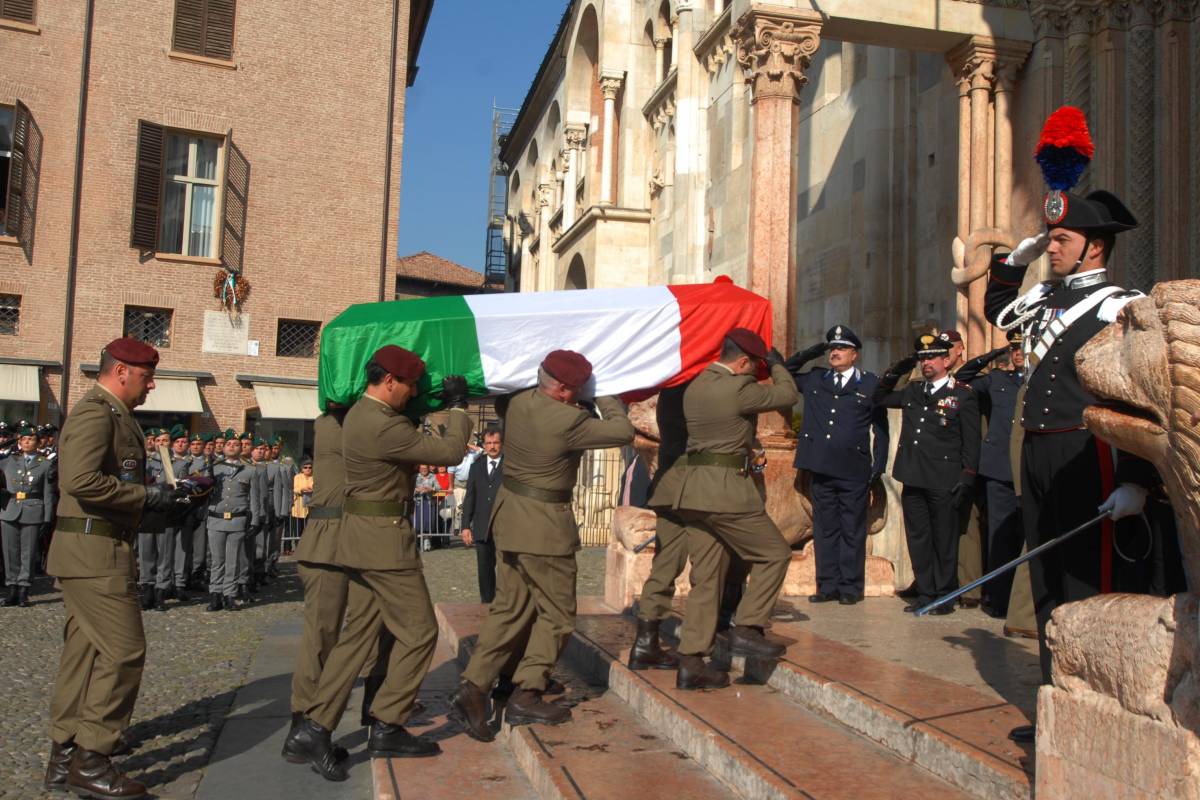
[784, 325, 888, 606]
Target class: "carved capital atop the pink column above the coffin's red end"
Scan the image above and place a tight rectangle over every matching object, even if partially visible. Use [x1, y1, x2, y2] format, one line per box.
[732, 8, 822, 102]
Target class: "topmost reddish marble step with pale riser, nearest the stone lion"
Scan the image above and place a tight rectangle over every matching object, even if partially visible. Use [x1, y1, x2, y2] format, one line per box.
[657, 616, 1033, 800]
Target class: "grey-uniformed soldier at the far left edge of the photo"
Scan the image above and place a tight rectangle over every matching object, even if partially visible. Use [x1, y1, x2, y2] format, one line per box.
[0, 427, 56, 608]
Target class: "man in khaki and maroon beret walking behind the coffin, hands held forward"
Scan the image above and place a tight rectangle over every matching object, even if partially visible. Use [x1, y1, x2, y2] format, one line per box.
[44, 338, 188, 800]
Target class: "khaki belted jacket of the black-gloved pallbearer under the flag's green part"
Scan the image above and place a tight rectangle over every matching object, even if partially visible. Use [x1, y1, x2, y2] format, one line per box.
[337, 395, 472, 570]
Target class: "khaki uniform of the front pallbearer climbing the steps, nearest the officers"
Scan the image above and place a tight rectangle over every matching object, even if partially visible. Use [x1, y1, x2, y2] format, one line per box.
[649, 363, 799, 656]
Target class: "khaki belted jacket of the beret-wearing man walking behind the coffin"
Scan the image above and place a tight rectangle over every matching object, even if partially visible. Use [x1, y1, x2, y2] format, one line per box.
[47, 385, 146, 578]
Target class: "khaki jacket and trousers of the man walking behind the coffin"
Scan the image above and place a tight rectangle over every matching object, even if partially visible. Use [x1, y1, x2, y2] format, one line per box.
[48, 385, 146, 756]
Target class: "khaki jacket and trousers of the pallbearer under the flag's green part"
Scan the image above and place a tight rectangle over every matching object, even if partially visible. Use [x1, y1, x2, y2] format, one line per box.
[307, 395, 472, 730]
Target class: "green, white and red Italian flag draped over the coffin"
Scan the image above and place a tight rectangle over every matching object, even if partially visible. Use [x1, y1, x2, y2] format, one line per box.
[318, 277, 772, 414]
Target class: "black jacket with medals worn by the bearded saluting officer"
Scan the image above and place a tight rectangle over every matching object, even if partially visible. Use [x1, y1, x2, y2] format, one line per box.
[875, 374, 979, 489]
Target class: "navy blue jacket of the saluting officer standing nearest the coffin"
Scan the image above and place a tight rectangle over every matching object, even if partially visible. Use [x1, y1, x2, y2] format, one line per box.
[794, 368, 888, 482]
